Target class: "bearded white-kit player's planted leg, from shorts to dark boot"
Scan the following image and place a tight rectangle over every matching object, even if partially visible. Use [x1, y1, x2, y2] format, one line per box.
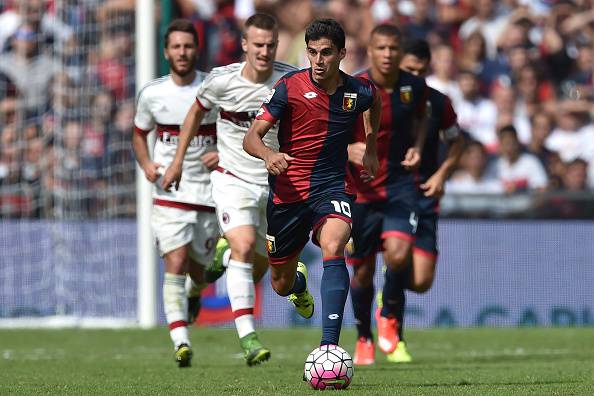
[152, 205, 196, 367]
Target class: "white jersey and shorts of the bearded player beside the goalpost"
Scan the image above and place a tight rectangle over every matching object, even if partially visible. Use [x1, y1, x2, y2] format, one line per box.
[134, 72, 219, 265]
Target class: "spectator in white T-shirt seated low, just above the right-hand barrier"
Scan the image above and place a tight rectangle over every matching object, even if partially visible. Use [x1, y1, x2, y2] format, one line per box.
[494, 125, 547, 194]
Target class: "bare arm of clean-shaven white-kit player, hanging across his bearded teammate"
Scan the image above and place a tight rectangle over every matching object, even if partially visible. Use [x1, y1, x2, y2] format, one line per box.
[161, 101, 205, 191]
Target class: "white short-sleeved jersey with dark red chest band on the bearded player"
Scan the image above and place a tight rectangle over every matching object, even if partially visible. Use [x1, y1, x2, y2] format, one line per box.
[134, 72, 217, 206]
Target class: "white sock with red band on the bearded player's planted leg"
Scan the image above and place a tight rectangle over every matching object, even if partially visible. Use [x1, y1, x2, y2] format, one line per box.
[163, 272, 190, 347]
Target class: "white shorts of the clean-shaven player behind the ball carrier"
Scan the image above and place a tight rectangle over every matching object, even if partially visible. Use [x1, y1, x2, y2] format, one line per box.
[210, 171, 269, 257]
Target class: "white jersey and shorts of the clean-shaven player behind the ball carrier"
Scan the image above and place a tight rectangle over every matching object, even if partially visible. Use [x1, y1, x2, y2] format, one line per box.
[196, 62, 297, 256]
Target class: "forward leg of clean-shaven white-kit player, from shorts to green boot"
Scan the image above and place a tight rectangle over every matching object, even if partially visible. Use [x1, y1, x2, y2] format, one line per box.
[211, 172, 270, 365]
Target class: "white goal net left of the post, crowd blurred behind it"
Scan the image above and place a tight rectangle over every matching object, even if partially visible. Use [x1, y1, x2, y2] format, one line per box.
[0, 0, 136, 326]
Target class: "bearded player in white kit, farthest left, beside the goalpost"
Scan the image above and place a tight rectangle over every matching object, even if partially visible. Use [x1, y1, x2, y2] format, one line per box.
[132, 19, 227, 367]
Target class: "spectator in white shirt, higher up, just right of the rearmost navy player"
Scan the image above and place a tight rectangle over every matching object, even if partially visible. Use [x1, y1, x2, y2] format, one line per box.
[454, 70, 498, 153]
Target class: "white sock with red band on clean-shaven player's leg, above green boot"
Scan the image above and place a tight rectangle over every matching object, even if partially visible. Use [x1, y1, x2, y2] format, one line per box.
[227, 260, 255, 338]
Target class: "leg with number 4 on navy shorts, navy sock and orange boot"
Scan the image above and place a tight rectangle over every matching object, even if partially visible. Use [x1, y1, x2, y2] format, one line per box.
[376, 202, 418, 353]
